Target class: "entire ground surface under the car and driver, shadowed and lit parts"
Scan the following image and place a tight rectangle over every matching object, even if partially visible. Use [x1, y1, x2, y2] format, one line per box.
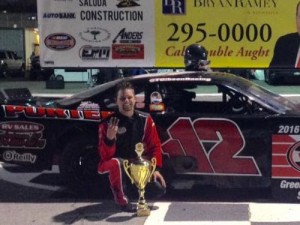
[0, 164, 300, 225]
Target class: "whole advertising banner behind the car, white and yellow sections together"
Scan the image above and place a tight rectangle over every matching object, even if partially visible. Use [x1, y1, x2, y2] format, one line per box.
[38, 0, 300, 68]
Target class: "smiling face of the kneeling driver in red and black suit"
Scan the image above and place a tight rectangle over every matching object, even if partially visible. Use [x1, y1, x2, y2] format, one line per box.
[117, 89, 136, 116]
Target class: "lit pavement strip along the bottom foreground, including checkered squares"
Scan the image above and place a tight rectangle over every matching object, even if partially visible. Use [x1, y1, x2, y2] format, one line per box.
[0, 201, 300, 225]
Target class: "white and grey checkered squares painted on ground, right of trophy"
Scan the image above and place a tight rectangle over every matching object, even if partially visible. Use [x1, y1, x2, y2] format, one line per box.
[144, 202, 300, 225]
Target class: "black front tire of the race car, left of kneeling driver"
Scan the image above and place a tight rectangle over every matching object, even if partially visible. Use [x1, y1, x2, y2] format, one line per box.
[59, 136, 109, 195]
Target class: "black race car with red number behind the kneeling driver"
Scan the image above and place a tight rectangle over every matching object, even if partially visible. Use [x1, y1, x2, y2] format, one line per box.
[0, 71, 300, 202]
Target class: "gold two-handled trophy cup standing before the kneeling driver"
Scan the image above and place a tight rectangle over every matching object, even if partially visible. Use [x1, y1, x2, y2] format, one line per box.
[123, 143, 156, 216]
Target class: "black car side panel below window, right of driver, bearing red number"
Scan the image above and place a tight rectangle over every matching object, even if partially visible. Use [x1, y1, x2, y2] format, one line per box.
[153, 114, 300, 197]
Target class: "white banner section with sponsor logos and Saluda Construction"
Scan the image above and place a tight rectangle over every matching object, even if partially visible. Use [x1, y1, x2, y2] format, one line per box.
[37, 0, 155, 68]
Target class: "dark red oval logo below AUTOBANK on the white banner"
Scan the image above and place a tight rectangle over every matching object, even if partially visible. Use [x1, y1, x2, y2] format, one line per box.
[44, 33, 76, 51]
